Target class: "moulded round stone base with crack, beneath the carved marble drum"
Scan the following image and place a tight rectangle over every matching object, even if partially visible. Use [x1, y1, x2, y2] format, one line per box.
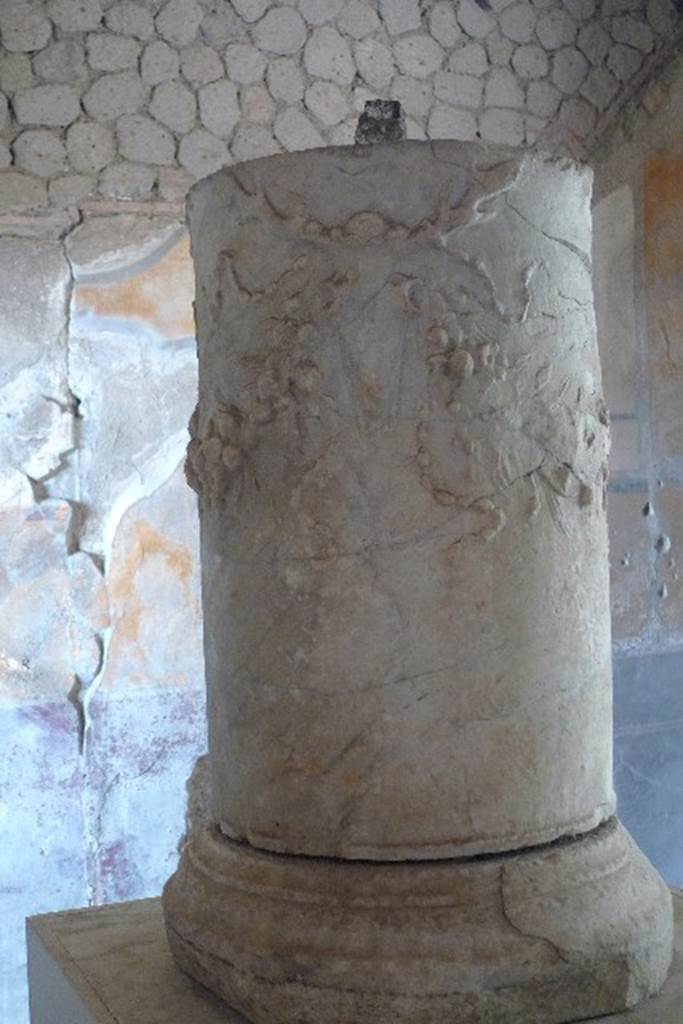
[164, 819, 673, 1024]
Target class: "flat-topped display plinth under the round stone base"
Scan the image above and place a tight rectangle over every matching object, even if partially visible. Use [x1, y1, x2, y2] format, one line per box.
[27, 892, 683, 1024]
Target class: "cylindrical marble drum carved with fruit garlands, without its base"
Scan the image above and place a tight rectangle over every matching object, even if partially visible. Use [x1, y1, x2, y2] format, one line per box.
[188, 142, 613, 860]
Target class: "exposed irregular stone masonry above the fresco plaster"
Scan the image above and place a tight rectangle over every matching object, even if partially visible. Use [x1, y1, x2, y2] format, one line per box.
[0, 0, 678, 212]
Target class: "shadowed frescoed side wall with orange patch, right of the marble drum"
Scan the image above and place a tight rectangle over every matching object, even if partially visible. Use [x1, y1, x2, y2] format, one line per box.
[594, 58, 683, 886]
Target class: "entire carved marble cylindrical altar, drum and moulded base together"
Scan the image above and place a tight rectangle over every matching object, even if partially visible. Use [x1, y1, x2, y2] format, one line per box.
[164, 142, 672, 1024]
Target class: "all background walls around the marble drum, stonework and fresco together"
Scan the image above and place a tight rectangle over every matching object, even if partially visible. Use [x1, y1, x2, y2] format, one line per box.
[0, 0, 683, 1024]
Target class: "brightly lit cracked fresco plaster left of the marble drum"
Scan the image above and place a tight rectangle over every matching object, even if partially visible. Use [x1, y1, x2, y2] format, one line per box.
[0, 213, 205, 1024]
